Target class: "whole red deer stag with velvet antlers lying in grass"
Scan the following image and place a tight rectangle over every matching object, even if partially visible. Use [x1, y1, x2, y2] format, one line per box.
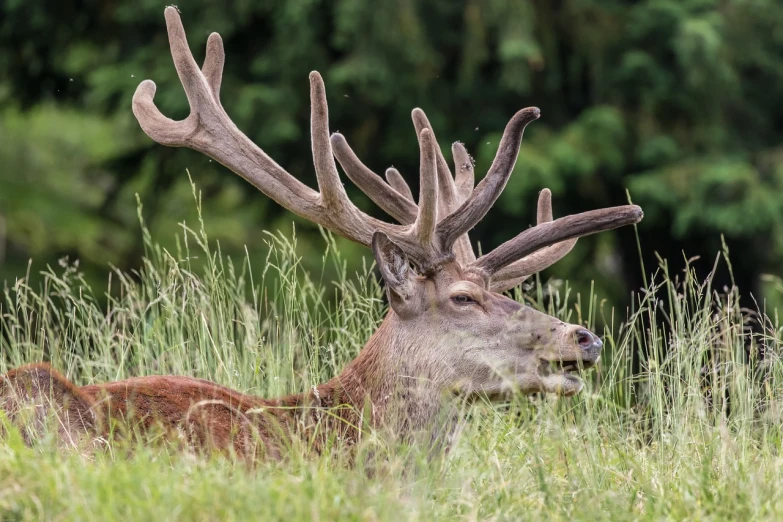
[0, 7, 643, 460]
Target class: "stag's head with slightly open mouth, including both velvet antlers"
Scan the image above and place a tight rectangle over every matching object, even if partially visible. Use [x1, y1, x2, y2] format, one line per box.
[133, 7, 643, 404]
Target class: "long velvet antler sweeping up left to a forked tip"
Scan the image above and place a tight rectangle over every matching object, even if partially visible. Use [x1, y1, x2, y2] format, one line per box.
[133, 7, 453, 270]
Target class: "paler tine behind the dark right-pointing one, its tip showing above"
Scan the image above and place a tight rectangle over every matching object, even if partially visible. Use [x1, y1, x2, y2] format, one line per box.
[490, 189, 577, 292]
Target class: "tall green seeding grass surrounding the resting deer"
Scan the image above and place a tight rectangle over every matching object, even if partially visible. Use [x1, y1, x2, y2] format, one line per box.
[0, 198, 783, 522]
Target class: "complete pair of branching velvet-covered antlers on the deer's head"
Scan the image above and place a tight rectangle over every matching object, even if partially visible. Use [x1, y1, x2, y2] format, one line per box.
[133, 7, 642, 289]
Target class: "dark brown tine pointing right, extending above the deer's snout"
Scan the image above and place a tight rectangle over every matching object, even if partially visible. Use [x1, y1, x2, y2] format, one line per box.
[474, 205, 644, 276]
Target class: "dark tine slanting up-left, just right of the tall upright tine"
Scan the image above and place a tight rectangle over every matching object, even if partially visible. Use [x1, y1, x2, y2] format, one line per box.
[331, 132, 418, 225]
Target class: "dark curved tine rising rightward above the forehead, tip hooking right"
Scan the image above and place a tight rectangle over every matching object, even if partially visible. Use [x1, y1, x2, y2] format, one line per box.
[438, 107, 541, 248]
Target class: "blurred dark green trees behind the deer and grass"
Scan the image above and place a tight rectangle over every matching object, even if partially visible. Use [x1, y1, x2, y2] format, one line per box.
[0, 0, 783, 306]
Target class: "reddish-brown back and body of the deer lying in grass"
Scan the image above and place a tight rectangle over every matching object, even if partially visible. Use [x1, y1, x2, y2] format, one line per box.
[0, 363, 368, 459]
